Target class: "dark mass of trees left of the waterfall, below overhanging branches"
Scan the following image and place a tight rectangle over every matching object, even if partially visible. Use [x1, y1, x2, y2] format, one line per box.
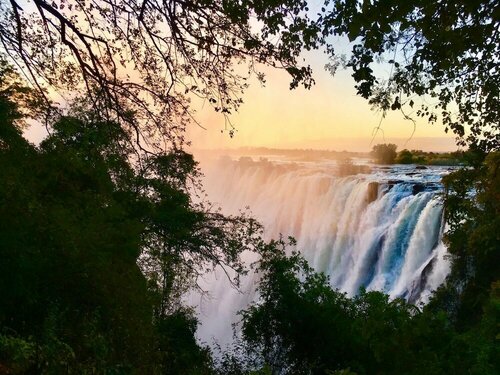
[0, 67, 259, 373]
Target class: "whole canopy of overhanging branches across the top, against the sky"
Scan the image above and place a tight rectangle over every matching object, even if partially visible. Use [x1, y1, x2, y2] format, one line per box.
[0, 0, 500, 150]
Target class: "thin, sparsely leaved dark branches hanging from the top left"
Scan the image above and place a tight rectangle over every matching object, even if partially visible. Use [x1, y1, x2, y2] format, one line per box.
[0, 0, 315, 148]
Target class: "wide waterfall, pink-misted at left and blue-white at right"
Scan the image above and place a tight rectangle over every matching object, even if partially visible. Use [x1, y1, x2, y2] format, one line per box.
[192, 158, 449, 344]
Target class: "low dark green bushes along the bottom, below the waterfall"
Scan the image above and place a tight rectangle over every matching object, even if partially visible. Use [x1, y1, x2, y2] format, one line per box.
[231, 232, 500, 374]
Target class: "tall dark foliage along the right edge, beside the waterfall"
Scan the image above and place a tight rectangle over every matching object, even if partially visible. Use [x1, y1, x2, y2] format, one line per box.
[427, 149, 500, 374]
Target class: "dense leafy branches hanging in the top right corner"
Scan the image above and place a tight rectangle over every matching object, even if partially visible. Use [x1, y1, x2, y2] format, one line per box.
[318, 0, 500, 150]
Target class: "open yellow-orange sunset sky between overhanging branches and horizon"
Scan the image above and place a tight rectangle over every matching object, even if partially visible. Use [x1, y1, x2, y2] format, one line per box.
[188, 51, 457, 151]
